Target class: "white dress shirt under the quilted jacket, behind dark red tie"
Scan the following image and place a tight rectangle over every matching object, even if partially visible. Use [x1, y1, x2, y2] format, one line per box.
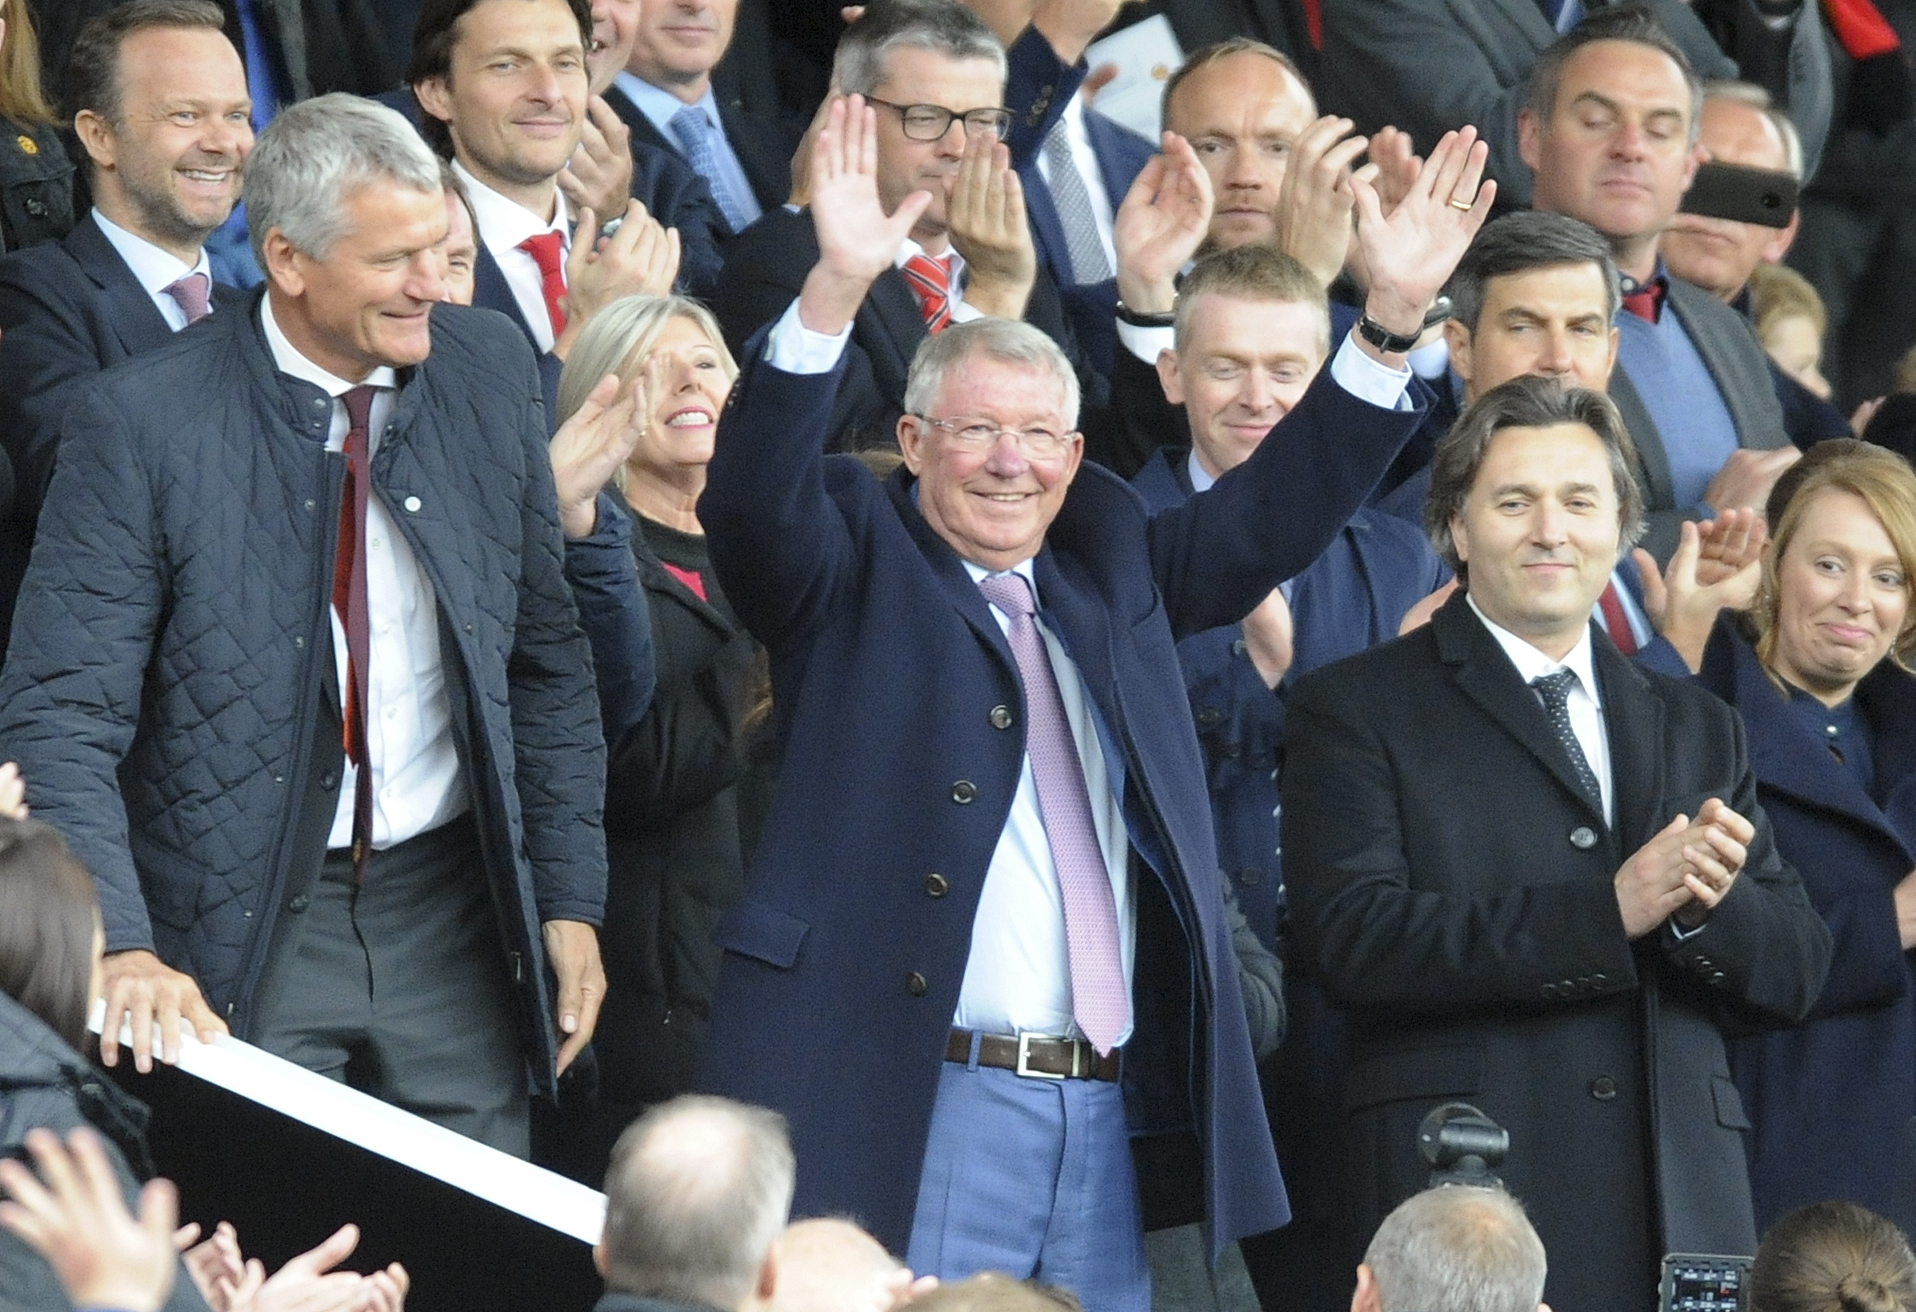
[261, 297, 471, 850]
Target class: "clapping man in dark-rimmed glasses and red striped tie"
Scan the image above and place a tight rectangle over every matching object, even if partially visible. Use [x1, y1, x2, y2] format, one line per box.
[713, 0, 1102, 448]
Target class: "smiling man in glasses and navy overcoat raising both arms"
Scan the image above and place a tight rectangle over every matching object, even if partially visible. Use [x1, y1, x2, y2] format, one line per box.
[699, 84, 1494, 1310]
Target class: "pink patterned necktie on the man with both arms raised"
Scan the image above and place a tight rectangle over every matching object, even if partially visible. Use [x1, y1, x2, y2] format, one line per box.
[979, 575, 1130, 1053]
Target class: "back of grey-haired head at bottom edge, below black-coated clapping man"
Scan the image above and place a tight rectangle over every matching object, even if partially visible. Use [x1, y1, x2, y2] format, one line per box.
[1351, 1186, 1550, 1312]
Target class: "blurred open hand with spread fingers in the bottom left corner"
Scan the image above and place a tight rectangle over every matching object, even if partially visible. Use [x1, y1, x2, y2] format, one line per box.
[0, 1126, 180, 1312]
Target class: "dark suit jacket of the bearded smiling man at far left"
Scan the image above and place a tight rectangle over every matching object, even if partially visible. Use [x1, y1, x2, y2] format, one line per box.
[0, 215, 245, 651]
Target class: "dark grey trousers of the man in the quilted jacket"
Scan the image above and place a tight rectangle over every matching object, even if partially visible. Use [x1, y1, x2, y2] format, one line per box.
[253, 816, 531, 1157]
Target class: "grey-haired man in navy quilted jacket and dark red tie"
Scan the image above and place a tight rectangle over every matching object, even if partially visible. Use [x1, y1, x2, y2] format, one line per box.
[0, 96, 605, 1155]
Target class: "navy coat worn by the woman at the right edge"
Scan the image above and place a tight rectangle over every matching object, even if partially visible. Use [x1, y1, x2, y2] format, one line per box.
[1698, 619, 1916, 1228]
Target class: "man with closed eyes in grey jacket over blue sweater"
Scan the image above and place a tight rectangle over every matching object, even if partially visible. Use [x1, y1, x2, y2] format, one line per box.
[1517, 10, 1795, 561]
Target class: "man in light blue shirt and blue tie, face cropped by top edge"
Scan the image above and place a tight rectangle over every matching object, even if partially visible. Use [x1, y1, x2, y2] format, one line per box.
[605, 0, 799, 236]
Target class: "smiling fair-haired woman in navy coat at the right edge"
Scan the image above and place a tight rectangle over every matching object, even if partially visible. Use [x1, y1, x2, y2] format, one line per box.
[1701, 439, 1916, 1228]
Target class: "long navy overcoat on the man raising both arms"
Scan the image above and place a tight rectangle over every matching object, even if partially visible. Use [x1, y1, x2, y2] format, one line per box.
[699, 321, 1418, 1251]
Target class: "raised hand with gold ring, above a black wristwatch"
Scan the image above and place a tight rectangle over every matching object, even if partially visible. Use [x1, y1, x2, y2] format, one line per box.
[1348, 128, 1496, 364]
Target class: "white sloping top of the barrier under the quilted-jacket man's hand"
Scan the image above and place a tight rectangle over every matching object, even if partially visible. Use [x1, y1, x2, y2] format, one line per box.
[90, 1002, 605, 1243]
